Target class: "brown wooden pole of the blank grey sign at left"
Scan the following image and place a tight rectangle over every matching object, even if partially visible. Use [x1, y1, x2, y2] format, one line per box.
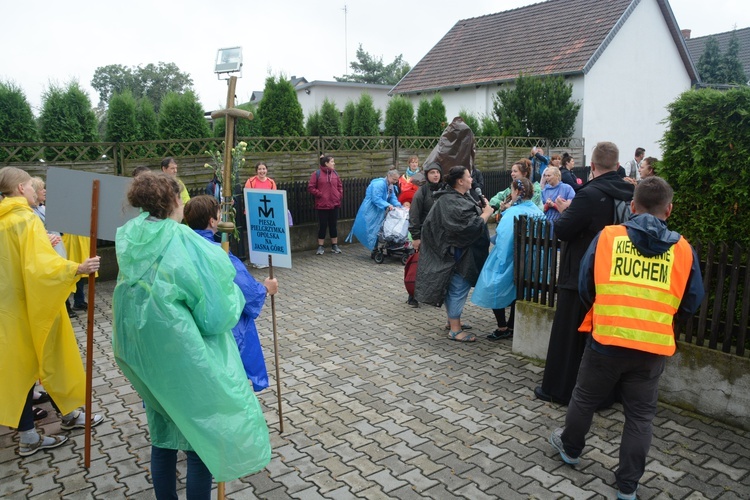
[83, 179, 99, 469]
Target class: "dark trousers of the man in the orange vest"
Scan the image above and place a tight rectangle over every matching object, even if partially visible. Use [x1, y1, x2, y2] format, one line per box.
[562, 343, 667, 493]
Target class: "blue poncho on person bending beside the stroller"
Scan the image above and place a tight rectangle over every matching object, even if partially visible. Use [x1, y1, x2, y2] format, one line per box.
[346, 177, 401, 250]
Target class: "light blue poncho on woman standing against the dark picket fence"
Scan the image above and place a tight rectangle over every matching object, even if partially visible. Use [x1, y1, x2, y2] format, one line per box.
[471, 200, 544, 309]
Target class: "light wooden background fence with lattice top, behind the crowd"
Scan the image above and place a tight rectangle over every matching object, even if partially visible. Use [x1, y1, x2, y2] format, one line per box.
[0, 136, 585, 189]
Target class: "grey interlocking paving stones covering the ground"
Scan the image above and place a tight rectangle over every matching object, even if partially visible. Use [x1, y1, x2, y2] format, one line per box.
[0, 245, 750, 500]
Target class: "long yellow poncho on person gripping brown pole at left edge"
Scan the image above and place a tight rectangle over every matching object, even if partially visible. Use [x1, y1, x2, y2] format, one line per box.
[0, 196, 86, 427]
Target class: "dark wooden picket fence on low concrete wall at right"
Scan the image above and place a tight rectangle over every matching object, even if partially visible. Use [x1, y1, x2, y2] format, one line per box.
[514, 217, 750, 357]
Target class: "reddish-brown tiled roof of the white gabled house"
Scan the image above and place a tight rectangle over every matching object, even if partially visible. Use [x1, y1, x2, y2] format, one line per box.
[392, 0, 692, 94]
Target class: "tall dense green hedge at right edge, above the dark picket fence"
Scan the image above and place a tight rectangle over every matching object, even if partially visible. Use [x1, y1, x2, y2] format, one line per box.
[656, 87, 750, 248]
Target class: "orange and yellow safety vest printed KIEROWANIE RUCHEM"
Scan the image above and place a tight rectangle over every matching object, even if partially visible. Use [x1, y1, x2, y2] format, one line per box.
[578, 225, 693, 356]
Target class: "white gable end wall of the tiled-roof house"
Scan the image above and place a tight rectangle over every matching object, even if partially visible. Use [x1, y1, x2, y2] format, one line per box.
[581, 0, 691, 163]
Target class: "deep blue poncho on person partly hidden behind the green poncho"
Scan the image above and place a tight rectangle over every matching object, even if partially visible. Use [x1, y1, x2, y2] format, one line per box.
[195, 229, 268, 392]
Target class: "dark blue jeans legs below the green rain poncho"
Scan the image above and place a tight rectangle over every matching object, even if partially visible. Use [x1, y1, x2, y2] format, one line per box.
[151, 446, 212, 500]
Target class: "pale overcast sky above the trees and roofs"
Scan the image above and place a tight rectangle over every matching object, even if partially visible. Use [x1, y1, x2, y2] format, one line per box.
[0, 0, 750, 115]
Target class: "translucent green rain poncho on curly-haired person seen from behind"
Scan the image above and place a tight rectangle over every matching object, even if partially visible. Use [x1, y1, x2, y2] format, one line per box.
[112, 213, 271, 481]
